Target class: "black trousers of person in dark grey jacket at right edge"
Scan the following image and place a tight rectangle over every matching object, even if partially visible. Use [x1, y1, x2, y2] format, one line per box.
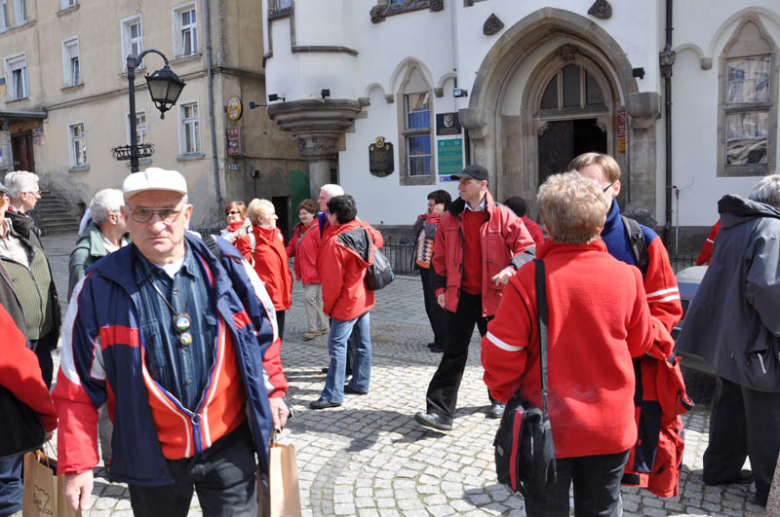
[703, 377, 780, 499]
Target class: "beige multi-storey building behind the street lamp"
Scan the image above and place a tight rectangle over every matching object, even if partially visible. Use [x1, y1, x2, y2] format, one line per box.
[0, 0, 308, 228]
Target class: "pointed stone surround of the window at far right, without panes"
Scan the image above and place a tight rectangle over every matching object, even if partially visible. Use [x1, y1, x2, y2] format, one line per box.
[717, 13, 780, 177]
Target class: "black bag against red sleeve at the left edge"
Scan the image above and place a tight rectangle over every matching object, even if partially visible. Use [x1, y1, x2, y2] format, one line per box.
[0, 386, 46, 459]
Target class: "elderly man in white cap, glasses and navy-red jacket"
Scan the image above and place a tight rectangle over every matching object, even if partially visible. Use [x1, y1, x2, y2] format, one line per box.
[54, 168, 288, 517]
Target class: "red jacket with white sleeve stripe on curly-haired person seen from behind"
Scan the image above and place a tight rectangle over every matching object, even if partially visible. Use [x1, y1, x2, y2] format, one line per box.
[482, 240, 653, 458]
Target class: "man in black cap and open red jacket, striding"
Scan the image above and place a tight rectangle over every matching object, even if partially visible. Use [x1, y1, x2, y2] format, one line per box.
[414, 165, 535, 431]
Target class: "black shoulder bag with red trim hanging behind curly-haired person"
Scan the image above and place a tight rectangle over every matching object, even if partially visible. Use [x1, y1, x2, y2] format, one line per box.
[493, 259, 556, 496]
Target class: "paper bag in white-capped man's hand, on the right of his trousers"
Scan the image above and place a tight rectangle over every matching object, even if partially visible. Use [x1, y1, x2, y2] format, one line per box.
[268, 442, 301, 517]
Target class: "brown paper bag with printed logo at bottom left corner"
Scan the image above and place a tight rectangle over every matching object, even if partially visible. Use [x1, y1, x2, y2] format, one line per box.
[22, 451, 81, 517]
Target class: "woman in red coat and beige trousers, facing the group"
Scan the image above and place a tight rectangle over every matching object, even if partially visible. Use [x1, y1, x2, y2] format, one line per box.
[287, 199, 329, 341]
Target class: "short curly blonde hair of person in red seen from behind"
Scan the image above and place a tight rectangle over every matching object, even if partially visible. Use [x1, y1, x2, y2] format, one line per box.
[536, 172, 608, 244]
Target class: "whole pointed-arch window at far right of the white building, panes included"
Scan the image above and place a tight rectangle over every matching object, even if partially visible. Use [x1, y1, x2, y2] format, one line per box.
[718, 15, 780, 176]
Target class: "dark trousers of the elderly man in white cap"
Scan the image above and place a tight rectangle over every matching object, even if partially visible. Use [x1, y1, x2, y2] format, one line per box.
[129, 423, 257, 517]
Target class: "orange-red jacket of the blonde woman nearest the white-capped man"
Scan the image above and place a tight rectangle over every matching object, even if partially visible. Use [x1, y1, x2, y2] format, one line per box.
[252, 225, 292, 311]
